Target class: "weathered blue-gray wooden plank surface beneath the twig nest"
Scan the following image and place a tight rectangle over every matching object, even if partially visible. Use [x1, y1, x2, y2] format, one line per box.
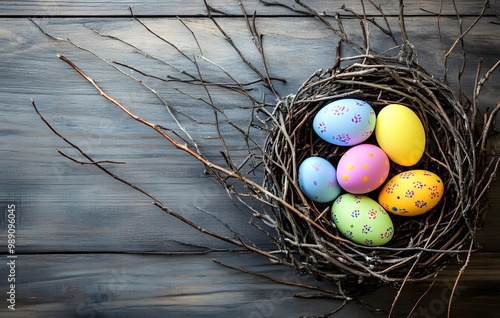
[0, 0, 500, 317]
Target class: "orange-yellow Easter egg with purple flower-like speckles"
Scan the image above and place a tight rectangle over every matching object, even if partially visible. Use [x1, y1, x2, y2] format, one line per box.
[378, 170, 444, 216]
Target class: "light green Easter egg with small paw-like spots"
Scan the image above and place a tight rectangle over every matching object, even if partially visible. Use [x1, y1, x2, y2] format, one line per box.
[331, 193, 394, 246]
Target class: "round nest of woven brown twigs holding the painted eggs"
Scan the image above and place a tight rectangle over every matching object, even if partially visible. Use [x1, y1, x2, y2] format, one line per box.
[264, 56, 491, 294]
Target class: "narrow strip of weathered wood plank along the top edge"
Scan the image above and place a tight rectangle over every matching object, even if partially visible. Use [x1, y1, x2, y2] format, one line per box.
[0, 0, 499, 17]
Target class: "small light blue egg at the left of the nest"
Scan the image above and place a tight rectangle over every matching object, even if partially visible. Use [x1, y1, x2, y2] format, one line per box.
[298, 157, 342, 203]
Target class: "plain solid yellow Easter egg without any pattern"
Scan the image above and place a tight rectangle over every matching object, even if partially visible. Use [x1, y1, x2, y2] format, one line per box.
[375, 104, 425, 166]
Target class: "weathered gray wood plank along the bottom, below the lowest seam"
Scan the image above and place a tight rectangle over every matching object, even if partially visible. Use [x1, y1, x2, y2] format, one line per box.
[0, 253, 500, 318]
